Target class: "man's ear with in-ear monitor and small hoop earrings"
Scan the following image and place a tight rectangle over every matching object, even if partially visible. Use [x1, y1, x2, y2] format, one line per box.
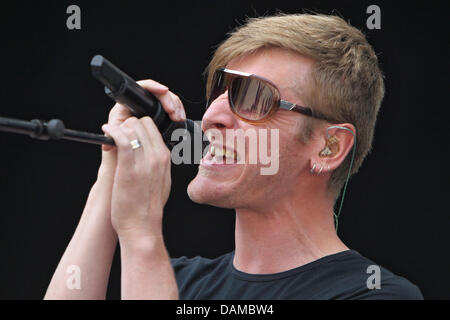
[311, 123, 356, 174]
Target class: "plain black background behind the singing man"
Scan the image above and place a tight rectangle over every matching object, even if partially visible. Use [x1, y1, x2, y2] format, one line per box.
[0, 1, 450, 299]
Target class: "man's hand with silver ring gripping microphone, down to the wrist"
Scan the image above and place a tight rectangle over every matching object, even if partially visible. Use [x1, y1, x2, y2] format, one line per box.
[102, 80, 186, 241]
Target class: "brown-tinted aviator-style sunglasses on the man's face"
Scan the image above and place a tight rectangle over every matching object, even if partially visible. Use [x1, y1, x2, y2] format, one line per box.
[206, 68, 334, 123]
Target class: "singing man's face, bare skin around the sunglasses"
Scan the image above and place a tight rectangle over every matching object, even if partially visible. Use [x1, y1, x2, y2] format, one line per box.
[188, 49, 313, 209]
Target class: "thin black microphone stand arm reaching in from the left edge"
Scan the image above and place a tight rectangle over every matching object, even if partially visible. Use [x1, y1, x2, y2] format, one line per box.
[0, 117, 115, 146]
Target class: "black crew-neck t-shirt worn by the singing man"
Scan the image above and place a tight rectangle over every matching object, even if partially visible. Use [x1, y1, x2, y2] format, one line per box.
[171, 250, 423, 300]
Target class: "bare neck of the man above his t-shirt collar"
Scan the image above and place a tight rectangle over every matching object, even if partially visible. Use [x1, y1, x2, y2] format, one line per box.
[233, 189, 348, 274]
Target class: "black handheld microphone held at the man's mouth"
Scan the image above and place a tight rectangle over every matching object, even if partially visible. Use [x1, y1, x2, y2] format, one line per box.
[91, 55, 205, 150]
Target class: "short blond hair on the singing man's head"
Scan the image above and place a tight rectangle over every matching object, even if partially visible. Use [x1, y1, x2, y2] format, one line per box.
[206, 14, 384, 194]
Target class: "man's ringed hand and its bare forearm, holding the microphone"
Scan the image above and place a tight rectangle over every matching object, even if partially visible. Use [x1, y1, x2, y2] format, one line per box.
[100, 80, 186, 299]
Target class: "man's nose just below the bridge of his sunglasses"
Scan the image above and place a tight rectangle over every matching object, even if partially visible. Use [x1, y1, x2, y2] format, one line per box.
[202, 90, 237, 131]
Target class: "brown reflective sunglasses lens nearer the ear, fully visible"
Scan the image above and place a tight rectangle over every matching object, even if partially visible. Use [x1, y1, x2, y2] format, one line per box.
[230, 77, 276, 121]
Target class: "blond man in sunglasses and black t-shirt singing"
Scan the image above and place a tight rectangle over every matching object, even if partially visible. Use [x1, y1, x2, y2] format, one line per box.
[46, 14, 422, 299]
